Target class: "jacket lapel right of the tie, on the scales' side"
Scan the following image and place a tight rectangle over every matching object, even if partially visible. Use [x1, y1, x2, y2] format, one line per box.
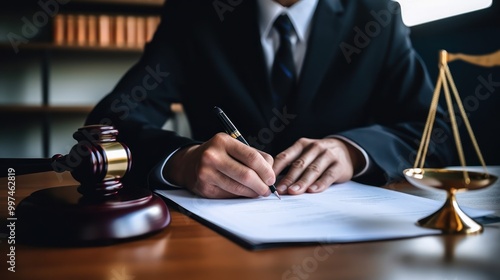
[293, 0, 343, 112]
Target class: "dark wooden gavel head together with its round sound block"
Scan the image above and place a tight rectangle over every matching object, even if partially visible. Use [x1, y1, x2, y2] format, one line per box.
[8, 125, 170, 245]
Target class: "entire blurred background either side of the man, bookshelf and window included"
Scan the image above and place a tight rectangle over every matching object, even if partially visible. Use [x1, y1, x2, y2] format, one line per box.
[0, 0, 500, 165]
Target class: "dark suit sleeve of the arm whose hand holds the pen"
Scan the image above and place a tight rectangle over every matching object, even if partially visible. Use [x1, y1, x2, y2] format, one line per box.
[86, 1, 196, 186]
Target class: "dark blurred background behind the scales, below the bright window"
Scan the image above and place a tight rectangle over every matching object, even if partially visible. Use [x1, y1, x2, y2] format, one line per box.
[408, 0, 500, 165]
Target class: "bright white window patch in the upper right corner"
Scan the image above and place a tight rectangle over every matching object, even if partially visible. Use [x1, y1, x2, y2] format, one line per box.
[394, 0, 493, 26]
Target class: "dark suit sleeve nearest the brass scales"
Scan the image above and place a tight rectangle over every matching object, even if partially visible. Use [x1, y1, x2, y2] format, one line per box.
[339, 3, 454, 186]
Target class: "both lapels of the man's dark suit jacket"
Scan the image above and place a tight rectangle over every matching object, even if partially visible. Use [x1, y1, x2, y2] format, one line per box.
[220, 0, 343, 122]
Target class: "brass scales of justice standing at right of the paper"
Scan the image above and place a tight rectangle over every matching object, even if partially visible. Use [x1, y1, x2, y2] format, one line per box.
[403, 50, 500, 234]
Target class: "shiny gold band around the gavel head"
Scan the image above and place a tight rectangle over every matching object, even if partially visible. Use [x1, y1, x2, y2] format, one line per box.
[100, 142, 129, 180]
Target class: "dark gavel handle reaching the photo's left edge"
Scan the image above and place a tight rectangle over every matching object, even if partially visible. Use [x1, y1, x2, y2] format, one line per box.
[0, 158, 59, 178]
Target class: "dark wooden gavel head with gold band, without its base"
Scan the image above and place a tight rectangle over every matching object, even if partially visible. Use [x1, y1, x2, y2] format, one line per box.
[52, 125, 132, 197]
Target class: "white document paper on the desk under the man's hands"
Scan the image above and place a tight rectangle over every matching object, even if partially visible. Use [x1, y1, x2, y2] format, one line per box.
[155, 182, 492, 248]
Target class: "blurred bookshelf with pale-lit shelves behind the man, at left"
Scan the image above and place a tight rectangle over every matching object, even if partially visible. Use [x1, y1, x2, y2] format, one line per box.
[0, 0, 188, 158]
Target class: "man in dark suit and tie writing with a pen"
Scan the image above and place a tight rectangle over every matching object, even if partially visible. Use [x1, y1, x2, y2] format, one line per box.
[87, 0, 452, 197]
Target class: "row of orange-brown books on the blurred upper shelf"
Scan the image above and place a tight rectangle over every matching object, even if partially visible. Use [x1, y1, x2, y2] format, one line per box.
[53, 14, 160, 48]
